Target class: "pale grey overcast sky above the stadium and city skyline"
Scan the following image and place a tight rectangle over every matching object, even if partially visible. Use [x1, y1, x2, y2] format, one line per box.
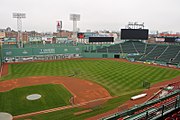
[0, 0, 180, 32]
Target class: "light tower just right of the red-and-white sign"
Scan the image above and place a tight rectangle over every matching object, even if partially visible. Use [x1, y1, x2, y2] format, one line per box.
[70, 14, 80, 41]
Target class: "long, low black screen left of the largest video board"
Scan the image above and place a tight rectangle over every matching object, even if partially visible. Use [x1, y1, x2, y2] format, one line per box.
[89, 37, 114, 42]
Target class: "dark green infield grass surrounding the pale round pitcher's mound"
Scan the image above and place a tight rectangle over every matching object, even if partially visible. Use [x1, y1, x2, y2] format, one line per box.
[0, 84, 72, 115]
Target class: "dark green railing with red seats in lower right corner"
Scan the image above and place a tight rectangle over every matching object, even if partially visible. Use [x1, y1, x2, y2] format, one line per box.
[100, 90, 180, 120]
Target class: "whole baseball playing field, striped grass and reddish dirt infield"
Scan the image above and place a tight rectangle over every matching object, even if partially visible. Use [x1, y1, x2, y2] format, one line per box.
[0, 59, 180, 120]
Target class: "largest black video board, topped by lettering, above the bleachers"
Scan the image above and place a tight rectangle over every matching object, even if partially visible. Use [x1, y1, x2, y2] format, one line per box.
[121, 29, 149, 40]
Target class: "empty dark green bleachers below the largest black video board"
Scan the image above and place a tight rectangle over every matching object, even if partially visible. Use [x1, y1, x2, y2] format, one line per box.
[91, 41, 180, 64]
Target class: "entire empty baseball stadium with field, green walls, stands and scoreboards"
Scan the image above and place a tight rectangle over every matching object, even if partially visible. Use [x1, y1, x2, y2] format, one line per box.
[0, 24, 180, 120]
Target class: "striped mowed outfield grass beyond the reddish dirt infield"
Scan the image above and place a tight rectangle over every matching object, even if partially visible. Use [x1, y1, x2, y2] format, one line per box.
[2, 60, 180, 95]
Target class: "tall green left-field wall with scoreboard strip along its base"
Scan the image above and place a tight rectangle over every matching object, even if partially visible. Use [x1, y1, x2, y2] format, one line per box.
[2, 46, 83, 62]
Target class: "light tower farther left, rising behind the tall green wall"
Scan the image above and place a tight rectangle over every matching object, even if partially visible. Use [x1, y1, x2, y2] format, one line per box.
[13, 13, 26, 47]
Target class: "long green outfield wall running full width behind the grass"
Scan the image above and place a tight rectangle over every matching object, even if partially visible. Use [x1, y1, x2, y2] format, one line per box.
[0, 44, 180, 68]
